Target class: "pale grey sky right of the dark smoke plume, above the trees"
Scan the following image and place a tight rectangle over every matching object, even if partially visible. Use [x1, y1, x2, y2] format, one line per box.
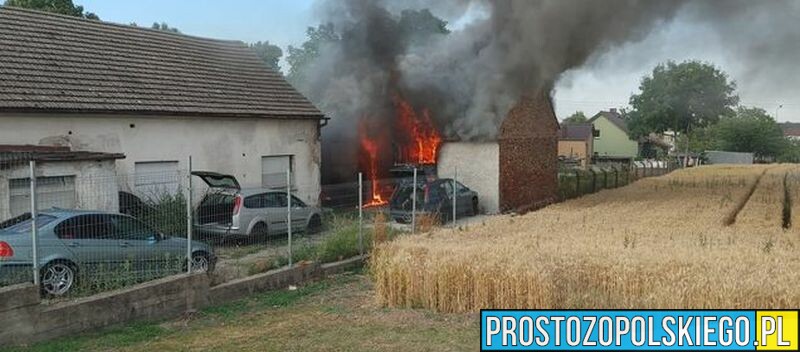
[555, 0, 800, 121]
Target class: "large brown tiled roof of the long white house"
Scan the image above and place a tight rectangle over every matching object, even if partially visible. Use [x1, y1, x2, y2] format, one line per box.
[0, 6, 323, 119]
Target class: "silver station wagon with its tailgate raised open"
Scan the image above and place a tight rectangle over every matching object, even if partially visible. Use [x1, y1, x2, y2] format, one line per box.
[192, 171, 322, 238]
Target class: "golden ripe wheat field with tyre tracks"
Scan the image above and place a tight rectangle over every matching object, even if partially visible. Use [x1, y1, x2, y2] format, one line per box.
[370, 165, 800, 312]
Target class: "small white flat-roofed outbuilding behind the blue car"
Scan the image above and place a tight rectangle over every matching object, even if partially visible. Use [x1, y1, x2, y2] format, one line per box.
[0, 145, 125, 219]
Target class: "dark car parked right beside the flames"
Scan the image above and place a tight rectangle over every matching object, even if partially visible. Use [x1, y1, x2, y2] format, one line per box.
[389, 177, 479, 223]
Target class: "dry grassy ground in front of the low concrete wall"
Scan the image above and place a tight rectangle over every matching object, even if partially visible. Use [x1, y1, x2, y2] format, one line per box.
[7, 274, 480, 351]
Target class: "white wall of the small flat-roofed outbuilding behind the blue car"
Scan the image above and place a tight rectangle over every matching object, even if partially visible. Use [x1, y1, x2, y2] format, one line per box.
[0, 160, 119, 220]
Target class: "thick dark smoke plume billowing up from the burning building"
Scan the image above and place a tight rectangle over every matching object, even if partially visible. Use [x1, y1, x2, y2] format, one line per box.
[301, 0, 683, 140]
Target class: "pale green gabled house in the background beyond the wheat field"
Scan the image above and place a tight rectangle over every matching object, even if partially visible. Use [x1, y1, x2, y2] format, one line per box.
[589, 109, 639, 158]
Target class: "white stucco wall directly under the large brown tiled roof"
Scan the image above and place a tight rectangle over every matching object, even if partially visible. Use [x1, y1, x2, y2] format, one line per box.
[0, 114, 320, 204]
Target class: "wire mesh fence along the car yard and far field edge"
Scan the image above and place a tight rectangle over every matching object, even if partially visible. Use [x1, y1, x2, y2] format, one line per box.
[0, 153, 672, 298]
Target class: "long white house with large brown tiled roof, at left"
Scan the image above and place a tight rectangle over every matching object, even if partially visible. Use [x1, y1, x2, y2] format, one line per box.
[0, 6, 324, 204]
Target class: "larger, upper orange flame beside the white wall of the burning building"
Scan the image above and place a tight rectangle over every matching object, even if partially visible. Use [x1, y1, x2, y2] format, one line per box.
[394, 96, 442, 165]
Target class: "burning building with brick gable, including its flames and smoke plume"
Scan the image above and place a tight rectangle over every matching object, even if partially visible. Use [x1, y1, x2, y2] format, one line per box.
[312, 0, 680, 209]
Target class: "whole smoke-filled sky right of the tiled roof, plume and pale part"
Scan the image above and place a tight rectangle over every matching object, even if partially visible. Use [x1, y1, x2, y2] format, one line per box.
[298, 0, 800, 180]
